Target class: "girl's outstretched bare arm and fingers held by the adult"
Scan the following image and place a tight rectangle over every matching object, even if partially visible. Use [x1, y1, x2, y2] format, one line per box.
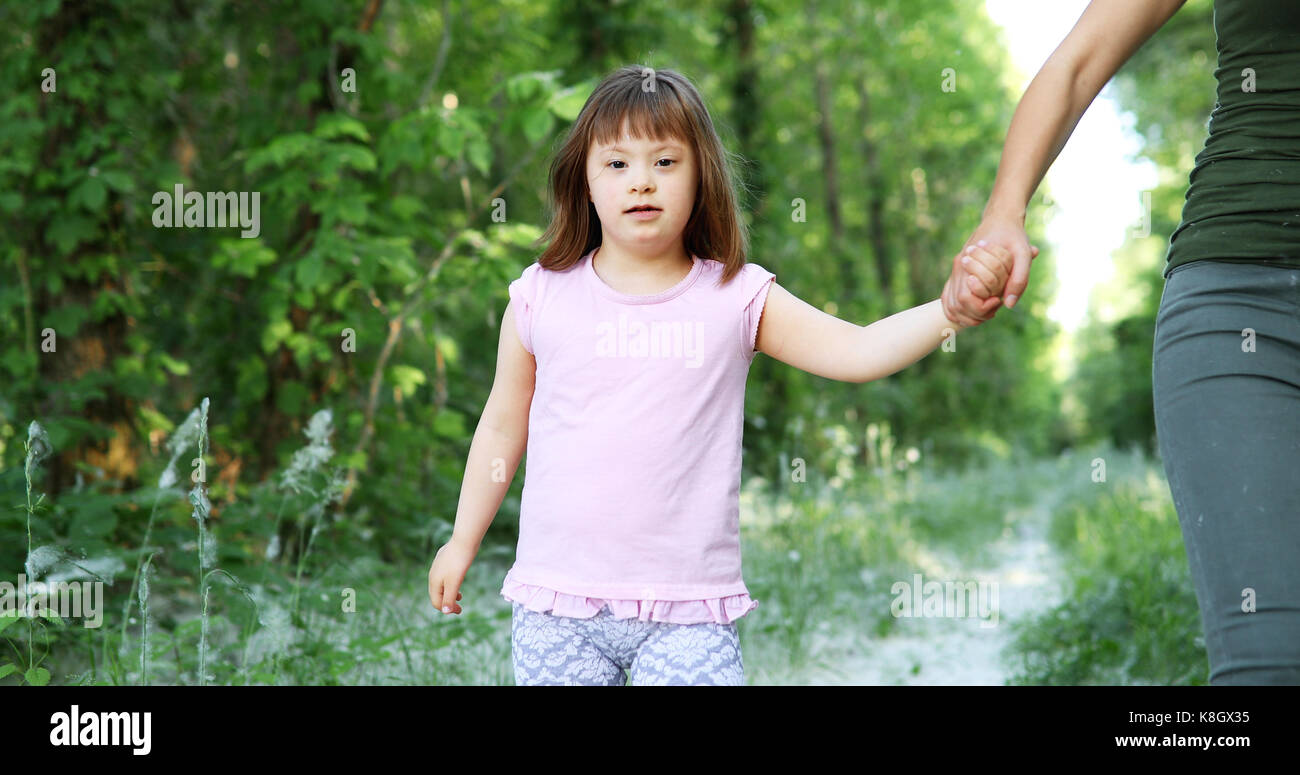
[755, 247, 1011, 382]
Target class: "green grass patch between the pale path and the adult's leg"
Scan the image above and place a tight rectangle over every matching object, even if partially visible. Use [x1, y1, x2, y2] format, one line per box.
[1011, 449, 1209, 685]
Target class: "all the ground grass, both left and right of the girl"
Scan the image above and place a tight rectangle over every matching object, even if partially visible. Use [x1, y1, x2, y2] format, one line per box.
[0, 403, 1208, 685]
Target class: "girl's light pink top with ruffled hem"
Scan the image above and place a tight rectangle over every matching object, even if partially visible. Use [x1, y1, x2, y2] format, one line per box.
[501, 251, 775, 624]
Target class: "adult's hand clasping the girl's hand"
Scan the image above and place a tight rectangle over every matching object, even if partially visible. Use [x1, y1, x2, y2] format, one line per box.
[941, 216, 1039, 326]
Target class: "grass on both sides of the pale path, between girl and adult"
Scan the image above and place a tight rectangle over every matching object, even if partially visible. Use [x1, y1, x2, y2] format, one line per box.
[741, 446, 1208, 684]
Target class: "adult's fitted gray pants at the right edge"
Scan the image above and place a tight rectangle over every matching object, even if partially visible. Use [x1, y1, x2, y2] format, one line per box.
[1152, 260, 1300, 685]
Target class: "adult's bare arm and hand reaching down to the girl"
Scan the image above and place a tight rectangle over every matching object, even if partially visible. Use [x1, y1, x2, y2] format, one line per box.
[941, 0, 1186, 325]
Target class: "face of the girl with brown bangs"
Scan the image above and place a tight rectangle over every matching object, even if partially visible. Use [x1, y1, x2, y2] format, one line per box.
[586, 125, 698, 254]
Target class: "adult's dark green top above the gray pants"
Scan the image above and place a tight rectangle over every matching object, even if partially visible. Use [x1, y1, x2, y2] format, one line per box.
[1165, 0, 1300, 277]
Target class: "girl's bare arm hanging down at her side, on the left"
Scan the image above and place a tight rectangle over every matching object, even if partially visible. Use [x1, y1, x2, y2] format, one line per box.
[429, 302, 537, 614]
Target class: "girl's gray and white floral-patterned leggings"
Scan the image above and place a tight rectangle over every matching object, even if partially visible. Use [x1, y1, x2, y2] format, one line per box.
[511, 602, 745, 687]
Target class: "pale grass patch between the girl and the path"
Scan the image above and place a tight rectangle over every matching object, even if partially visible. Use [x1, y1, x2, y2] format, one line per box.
[740, 439, 1035, 683]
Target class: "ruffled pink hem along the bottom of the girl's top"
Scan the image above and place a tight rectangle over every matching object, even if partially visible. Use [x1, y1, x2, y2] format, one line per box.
[501, 580, 758, 624]
